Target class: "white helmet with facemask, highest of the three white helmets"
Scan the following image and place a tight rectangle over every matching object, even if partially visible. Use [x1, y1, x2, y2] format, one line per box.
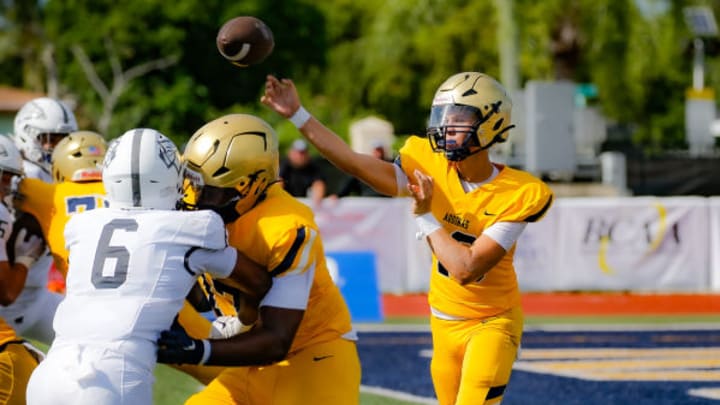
[13, 97, 77, 171]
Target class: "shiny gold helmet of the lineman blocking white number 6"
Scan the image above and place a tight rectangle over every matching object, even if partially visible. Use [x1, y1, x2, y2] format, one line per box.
[183, 114, 280, 223]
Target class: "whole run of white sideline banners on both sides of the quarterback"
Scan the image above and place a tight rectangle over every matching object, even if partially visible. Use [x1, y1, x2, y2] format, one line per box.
[305, 197, 720, 294]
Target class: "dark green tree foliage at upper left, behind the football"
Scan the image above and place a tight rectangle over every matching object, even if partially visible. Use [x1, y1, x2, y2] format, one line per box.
[0, 0, 326, 143]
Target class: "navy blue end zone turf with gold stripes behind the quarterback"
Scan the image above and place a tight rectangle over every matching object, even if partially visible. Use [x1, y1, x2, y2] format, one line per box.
[358, 330, 720, 405]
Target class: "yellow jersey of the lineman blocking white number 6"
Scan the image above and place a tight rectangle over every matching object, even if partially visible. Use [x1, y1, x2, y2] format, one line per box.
[224, 184, 352, 353]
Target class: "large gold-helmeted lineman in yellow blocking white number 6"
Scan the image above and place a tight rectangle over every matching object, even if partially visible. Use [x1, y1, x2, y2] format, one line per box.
[158, 114, 360, 405]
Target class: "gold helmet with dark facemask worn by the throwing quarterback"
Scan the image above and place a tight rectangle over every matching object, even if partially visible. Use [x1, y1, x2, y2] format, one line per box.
[427, 72, 515, 161]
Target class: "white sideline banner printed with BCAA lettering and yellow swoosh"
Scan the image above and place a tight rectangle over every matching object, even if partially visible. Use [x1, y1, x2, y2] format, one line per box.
[550, 197, 710, 291]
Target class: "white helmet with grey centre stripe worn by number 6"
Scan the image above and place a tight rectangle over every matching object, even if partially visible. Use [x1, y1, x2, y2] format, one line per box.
[102, 128, 184, 210]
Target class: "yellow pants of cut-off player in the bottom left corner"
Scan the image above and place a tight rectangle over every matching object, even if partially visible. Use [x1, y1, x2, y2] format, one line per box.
[0, 343, 38, 405]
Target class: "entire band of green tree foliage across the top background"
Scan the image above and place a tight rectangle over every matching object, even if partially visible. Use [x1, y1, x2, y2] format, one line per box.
[0, 0, 720, 151]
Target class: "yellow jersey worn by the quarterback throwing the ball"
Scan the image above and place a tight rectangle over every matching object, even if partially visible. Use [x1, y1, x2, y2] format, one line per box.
[398, 137, 553, 319]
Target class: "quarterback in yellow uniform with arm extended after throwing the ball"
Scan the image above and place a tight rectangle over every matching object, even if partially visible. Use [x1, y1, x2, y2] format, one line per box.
[261, 72, 553, 405]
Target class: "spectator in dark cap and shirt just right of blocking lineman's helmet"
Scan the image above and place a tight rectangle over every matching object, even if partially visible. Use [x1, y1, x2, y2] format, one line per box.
[280, 139, 326, 207]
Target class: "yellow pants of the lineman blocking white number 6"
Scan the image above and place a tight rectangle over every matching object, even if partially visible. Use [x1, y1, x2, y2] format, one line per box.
[185, 339, 360, 405]
